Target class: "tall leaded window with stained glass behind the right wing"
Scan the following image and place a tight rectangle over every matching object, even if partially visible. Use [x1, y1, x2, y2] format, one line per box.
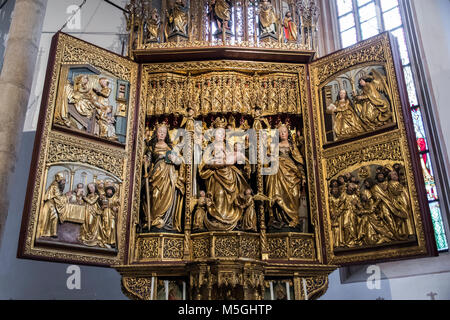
[335, 0, 448, 251]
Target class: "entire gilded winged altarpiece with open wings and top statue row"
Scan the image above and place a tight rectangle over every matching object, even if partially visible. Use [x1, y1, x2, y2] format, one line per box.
[19, 0, 436, 300]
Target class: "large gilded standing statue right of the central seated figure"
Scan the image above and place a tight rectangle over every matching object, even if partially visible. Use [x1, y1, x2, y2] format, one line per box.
[265, 124, 307, 231]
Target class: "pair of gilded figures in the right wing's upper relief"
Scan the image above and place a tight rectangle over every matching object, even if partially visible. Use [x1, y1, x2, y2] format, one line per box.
[327, 70, 393, 140]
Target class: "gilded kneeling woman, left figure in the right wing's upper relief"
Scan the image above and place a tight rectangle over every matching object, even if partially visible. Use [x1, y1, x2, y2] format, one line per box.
[327, 90, 365, 140]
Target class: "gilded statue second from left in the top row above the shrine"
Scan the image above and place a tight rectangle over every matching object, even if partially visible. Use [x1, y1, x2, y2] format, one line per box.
[165, 0, 189, 39]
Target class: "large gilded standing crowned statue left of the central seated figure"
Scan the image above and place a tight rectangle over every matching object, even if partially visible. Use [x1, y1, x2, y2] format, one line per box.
[143, 124, 185, 232]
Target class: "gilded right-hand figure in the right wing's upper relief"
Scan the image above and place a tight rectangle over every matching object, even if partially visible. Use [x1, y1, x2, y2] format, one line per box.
[353, 69, 392, 130]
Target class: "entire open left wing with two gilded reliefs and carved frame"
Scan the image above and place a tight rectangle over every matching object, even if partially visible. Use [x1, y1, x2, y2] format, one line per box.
[19, 33, 138, 265]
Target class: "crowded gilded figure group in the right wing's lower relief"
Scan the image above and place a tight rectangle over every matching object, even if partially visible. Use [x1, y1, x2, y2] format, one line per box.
[329, 164, 415, 249]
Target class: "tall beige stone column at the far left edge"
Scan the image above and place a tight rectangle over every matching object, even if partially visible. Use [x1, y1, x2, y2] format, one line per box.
[0, 0, 47, 247]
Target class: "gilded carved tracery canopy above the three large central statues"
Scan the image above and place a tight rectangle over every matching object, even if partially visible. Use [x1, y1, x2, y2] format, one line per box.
[147, 75, 300, 115]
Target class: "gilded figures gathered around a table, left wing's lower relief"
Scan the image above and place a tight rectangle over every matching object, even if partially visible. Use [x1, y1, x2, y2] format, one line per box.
[36, 173, 120, 248]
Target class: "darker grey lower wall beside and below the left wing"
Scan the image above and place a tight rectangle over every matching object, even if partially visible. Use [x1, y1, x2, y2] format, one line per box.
[0, 132, 126, 300]
